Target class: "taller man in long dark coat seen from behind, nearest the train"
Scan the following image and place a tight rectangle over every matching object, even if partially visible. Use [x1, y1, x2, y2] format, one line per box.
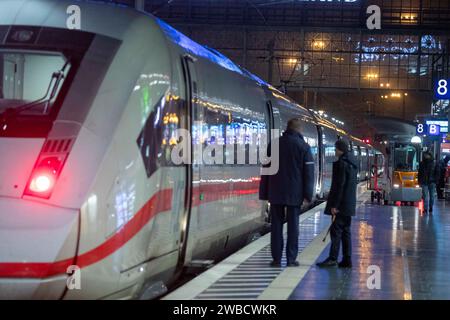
[259, 119, 314, 267]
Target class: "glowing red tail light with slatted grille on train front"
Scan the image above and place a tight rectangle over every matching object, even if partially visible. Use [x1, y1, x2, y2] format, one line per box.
[24, 139, 71, 199]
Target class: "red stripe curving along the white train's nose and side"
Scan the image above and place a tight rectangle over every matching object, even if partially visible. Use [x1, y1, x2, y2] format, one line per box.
[0, 178, 259, 278]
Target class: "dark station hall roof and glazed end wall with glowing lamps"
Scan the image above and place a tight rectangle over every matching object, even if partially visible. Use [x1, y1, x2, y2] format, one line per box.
[102, 0, 450, 139]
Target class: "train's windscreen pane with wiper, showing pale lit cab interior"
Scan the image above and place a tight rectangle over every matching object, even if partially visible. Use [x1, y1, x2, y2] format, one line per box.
[0, 49, 71, 117]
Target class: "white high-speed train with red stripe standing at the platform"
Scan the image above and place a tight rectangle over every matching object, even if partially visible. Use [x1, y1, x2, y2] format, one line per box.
[0, 0, 375, 299]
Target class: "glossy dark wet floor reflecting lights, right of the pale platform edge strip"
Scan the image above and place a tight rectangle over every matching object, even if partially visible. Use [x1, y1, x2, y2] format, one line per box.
[290, 201, 450, 300]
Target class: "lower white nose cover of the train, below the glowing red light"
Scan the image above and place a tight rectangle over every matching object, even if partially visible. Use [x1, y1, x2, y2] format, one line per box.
[0, 197, 78, 299]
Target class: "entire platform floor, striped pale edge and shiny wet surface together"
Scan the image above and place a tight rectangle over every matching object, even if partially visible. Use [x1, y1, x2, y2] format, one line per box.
[164, 192, 450, 300]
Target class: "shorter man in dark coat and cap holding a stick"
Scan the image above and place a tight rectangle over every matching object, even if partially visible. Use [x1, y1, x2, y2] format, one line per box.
[317, 140, 358, 268]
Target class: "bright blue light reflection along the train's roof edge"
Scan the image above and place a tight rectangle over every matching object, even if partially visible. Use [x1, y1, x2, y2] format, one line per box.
[156, 19, 268, 86]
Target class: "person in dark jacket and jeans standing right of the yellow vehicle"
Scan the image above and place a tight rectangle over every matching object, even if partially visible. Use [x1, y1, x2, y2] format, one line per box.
[419, 152, 439, 213]
